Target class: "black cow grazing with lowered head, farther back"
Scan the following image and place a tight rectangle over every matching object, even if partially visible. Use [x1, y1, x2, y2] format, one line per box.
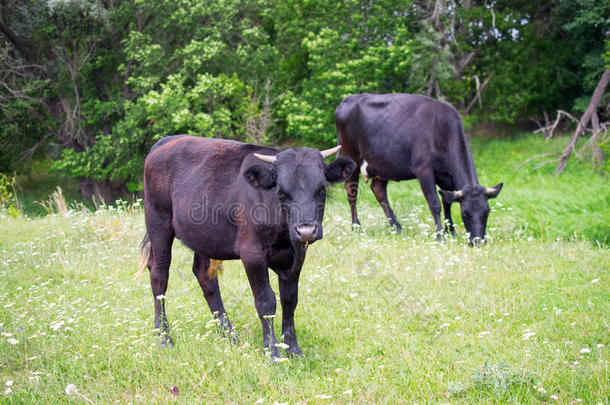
[335, 94, 502, 243]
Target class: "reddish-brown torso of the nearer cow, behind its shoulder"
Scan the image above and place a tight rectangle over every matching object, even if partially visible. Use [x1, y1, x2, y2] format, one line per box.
[144, 135, 269, 259]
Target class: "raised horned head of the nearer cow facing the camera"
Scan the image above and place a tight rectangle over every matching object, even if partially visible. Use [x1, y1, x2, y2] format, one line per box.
[244, 146, 356, 244]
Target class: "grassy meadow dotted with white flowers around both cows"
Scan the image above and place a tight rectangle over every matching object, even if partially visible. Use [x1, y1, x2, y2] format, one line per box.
[0, 134, 610, 404]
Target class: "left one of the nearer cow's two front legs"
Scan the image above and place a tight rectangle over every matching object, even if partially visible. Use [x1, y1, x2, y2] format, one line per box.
[242, 257, 280, 360]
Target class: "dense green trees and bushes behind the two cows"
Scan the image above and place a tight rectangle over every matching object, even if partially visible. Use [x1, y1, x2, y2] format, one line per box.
[0, 0, 610, 199]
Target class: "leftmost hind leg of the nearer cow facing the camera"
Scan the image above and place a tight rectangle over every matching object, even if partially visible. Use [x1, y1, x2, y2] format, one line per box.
[147, 223, 174, 346]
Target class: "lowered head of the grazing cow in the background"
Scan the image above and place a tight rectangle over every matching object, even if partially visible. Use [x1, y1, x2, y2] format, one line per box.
[439, 183, 502, 245]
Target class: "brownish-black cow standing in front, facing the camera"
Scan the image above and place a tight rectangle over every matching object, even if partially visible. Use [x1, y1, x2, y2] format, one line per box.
[135, 135, 356, 358]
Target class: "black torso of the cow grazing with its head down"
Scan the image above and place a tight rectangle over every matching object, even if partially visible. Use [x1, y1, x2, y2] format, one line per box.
[335, 93, 463, 180]
